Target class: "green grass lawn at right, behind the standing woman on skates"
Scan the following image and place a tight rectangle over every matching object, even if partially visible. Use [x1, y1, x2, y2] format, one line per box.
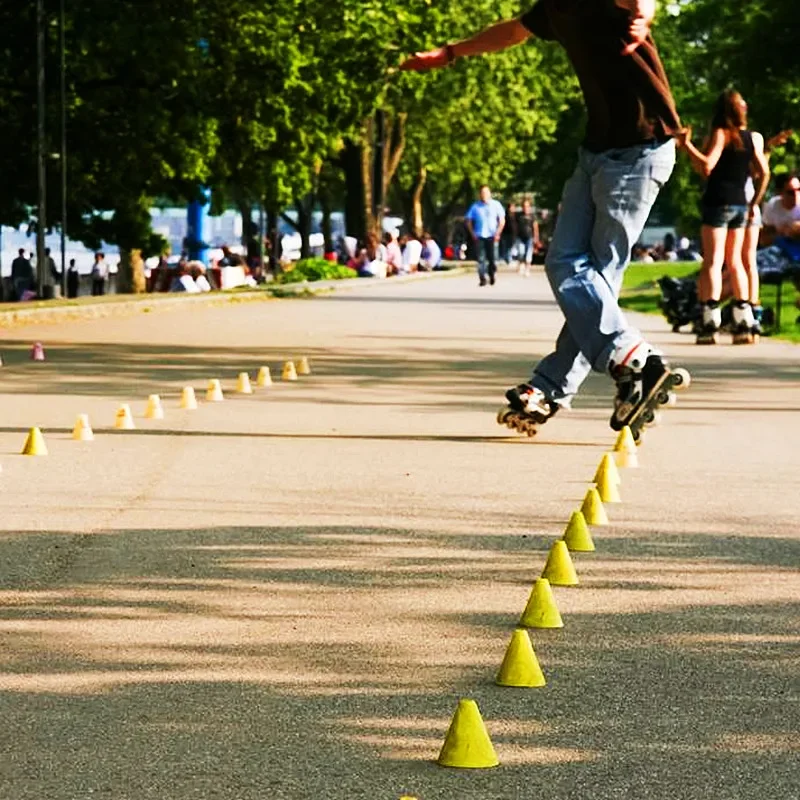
[620, 262, 800, 343]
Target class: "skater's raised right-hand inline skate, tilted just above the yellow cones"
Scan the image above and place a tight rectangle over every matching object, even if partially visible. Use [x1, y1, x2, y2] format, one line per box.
[610, 342, 691, 442]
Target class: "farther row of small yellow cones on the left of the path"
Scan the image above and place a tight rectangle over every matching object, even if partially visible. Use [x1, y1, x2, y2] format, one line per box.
[22, 357, 311, 456]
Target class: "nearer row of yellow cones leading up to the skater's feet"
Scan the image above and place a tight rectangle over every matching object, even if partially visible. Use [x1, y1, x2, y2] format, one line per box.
[437, 428, 639, 769]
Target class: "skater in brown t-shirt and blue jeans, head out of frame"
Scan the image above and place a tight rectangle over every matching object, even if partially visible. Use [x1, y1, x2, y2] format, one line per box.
[401, 0, 681, 438]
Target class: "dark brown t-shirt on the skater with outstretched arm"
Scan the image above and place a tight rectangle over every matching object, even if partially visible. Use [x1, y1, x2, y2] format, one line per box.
[520, 0, 681, 153]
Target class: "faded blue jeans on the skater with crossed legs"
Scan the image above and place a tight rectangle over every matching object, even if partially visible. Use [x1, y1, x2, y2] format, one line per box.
[531, 140, 675, 406]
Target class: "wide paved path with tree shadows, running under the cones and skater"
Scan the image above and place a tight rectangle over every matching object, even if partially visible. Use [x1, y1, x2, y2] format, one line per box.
[0, 275, 800, 800]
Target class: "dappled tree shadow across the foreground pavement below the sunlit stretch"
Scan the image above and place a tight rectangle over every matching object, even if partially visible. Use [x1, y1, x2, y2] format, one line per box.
[0, 526, 800, 800]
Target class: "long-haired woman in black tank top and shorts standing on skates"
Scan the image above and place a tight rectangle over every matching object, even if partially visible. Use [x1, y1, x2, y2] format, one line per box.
[678, 89, 769, 344]
